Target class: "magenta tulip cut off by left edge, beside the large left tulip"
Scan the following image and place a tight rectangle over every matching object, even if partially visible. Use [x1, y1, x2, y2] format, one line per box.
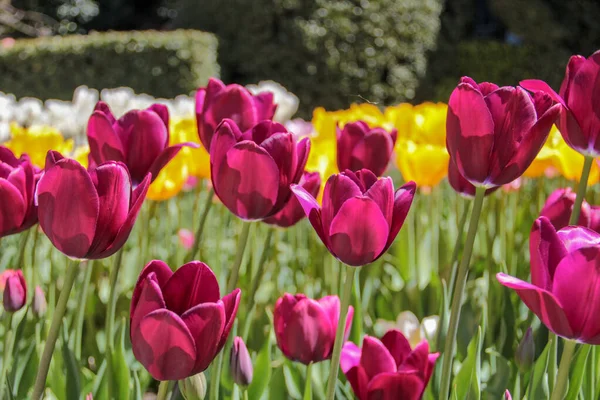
[0, 146, 38, 237]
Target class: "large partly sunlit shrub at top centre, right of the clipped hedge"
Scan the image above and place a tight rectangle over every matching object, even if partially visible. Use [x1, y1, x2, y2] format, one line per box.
[173, 0, 442, 116]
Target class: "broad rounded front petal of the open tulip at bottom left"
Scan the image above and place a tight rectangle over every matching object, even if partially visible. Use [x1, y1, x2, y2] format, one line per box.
[131, 309, 196, 381]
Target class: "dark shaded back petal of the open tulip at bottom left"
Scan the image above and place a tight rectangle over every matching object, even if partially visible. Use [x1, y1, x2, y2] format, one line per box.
[163, 261, 221, 315]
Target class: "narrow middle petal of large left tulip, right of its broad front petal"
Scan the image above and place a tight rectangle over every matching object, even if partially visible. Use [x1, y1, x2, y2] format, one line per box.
[89, 162, 131, 253]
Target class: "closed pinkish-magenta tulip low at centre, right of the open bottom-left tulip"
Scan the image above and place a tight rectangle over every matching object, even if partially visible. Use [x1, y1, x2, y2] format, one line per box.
[273, 293, 354, 365]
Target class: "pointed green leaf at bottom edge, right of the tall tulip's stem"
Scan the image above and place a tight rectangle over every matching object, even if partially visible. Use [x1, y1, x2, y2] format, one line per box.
[452, 327, 483, 400]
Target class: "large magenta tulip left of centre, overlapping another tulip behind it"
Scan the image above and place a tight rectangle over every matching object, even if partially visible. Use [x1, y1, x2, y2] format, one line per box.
[210, 119, 310, 220]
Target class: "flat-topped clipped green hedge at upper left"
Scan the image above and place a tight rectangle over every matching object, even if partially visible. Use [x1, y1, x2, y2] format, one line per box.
[0, 30, 219, 100]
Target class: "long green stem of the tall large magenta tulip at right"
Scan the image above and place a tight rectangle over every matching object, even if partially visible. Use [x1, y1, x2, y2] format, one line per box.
[439, 187, 485, 400]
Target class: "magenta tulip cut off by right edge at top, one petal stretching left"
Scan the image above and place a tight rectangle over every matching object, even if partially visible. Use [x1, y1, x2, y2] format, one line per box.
[521, 51, 600, 158]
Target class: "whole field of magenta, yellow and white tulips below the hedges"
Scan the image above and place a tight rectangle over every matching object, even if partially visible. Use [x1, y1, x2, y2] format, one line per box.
[0, 52, 600, 400]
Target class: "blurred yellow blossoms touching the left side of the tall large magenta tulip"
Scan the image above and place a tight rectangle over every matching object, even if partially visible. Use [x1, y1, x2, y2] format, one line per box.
[385, 102, 450, 188]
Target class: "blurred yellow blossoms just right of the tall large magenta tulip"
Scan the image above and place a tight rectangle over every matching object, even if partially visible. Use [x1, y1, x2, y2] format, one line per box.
[523, 126, 600, 184]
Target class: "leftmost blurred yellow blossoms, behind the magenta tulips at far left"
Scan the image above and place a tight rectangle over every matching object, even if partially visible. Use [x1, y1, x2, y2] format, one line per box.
[4, 122, 73, 168]
